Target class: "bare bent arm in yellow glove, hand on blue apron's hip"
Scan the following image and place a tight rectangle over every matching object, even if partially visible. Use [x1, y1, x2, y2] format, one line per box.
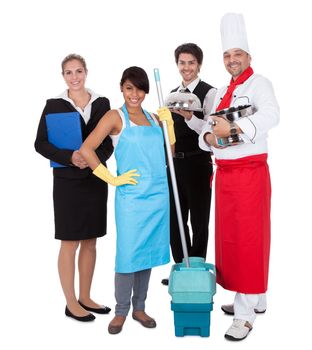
[79, 110, 139, 186]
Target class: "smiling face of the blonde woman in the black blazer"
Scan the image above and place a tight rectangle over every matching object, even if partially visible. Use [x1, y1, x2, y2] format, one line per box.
[63, 59, 87, 91]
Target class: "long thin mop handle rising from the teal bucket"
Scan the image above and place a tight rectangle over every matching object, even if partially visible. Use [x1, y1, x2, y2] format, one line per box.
[154, 68, 190, 267]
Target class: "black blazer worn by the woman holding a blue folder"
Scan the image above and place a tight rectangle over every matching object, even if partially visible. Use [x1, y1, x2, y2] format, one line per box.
[35, 97, 114, 179]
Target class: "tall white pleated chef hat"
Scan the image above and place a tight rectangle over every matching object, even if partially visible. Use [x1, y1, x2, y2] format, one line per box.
[220, 13, 250, 54]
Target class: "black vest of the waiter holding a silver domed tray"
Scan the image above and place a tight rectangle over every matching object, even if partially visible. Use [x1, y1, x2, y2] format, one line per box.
[171, 81, 213, 152]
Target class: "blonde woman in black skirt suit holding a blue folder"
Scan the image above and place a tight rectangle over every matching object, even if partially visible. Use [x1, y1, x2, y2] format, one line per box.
[35, 54, 113, 321]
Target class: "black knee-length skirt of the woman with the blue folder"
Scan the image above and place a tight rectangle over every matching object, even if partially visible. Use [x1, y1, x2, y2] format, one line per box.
[53, 174, 108, 241]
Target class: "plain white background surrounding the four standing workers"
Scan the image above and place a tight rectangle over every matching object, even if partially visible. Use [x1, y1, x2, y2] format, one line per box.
[0, 0, 312, 350]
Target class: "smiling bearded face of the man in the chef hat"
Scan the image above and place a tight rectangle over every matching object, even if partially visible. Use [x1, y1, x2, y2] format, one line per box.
[223, 49, 251, 80]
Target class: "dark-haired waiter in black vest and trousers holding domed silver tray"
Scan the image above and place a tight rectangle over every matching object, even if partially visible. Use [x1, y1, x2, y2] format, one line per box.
[162, 43, 216, 285]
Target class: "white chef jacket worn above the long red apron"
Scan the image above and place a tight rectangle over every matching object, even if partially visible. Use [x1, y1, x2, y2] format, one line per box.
[199, 74, 279, 159]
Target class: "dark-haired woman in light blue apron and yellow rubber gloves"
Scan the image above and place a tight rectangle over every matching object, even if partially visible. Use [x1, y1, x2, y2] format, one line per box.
[80, 67, 175, 334]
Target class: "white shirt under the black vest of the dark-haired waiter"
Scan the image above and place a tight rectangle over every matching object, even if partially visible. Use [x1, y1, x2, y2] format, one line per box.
[177, 77, 217, 134]
